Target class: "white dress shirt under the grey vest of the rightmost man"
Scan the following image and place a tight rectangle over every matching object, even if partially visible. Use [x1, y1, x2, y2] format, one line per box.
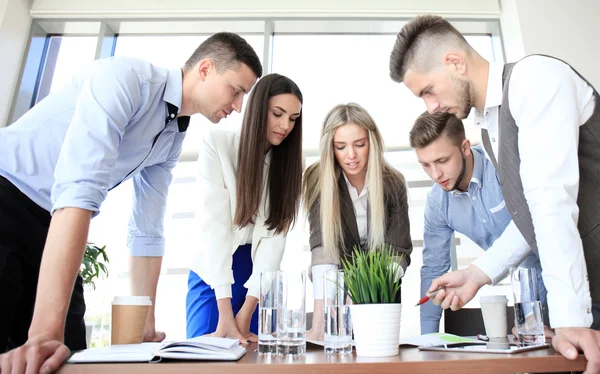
[474, 56, 595, 328]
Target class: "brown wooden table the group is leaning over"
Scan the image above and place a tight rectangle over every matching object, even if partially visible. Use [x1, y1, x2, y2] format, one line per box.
[58, 344, 586, 374]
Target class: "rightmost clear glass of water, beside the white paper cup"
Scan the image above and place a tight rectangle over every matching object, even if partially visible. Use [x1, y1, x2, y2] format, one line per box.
[510, 268, 546, 345]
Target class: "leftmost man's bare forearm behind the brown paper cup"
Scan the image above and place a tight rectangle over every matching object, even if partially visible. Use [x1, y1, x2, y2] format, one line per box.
[129, 256, 162, 327]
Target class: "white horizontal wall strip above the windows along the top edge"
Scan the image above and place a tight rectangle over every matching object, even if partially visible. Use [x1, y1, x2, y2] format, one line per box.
[32, 0, 500, 18]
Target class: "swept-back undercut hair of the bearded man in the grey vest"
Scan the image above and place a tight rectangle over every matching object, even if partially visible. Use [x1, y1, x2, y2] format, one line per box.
[390, 15, 472, 83]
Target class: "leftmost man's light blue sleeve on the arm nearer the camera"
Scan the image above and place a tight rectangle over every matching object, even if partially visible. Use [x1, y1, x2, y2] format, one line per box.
[51, 62, 142, 215]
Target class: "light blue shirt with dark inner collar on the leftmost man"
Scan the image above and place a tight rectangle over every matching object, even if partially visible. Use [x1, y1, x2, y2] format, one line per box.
[0, 57, 189, 256]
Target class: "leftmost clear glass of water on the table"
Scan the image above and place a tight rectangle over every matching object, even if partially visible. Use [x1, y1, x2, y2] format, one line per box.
[258, 271, 278, 354]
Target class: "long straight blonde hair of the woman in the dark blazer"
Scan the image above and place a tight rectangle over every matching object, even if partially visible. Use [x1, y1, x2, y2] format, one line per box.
[302, 103, 404, 260]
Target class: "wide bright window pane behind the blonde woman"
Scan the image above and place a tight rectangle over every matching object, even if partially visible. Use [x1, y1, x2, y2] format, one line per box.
[273, 32, 502, 336]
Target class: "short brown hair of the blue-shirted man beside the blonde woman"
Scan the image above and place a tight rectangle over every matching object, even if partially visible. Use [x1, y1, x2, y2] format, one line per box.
[409, 112, 466, 148]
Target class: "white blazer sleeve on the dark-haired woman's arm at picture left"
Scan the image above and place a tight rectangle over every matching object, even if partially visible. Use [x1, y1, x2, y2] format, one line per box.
[197, 133, 234, 299]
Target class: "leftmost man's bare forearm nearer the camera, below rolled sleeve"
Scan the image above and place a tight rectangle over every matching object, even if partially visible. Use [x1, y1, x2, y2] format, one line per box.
[29, 208, 92, 341]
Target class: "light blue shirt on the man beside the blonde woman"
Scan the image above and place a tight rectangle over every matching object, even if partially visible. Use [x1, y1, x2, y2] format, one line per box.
[420, 146, 546, 334]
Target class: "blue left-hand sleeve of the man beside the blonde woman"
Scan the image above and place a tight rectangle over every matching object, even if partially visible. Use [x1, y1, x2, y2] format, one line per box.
[420, 194, 454, 334]
